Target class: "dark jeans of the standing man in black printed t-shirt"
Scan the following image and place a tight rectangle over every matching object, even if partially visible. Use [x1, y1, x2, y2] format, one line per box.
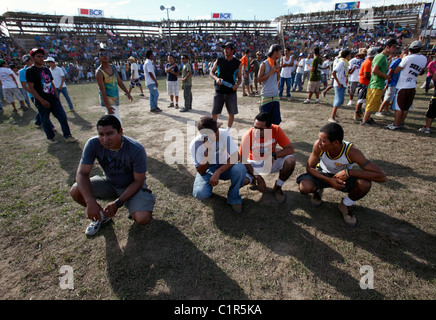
[35, 100, 71, 139]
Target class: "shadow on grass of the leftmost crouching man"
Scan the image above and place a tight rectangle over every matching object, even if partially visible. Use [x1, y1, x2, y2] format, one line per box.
[101, 220, 247, 300]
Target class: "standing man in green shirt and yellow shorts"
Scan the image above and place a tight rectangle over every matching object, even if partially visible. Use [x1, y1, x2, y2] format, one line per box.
[362, 39, 399, 125]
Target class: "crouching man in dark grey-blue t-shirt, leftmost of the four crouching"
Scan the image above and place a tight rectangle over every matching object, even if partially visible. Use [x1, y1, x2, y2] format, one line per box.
[70, 114, 156, 235]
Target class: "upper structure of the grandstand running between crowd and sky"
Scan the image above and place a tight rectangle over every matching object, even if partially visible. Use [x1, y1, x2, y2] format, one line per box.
[0, 3, 430, 51]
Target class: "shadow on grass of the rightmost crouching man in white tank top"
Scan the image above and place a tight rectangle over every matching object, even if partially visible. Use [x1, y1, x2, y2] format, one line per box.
[296, 199, 436, 281]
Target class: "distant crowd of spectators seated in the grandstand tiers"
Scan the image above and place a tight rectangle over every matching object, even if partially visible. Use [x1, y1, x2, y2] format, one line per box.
[0, 17, 422, 83]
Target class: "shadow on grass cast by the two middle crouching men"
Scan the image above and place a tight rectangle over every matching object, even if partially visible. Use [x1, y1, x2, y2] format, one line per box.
[209, 191, 384, 299]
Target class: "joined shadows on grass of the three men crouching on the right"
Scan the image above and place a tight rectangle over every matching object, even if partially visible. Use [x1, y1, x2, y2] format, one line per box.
[209, 184, 436, 299]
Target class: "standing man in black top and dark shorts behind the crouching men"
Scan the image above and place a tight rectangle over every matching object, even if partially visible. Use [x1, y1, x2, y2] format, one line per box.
[209, 42, 242, 130]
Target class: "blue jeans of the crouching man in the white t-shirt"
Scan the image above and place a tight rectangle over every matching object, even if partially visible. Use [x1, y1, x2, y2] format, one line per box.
[192, 162, 247, 204]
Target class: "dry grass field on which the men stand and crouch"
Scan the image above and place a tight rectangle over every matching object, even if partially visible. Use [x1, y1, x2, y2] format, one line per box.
[0, 77, 436, 300]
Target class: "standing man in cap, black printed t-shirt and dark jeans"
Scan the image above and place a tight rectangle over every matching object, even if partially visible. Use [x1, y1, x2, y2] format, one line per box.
[26, 48, 77, 143]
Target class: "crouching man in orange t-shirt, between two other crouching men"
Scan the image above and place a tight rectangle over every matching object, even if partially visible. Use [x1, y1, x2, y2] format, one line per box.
[239, 112, 296, 204]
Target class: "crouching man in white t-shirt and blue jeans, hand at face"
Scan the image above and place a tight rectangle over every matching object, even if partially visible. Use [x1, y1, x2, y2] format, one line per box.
[189, 116, 248, 213]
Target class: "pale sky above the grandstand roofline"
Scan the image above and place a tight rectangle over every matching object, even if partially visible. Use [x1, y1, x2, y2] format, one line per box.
[0, 0, 431, 21]
